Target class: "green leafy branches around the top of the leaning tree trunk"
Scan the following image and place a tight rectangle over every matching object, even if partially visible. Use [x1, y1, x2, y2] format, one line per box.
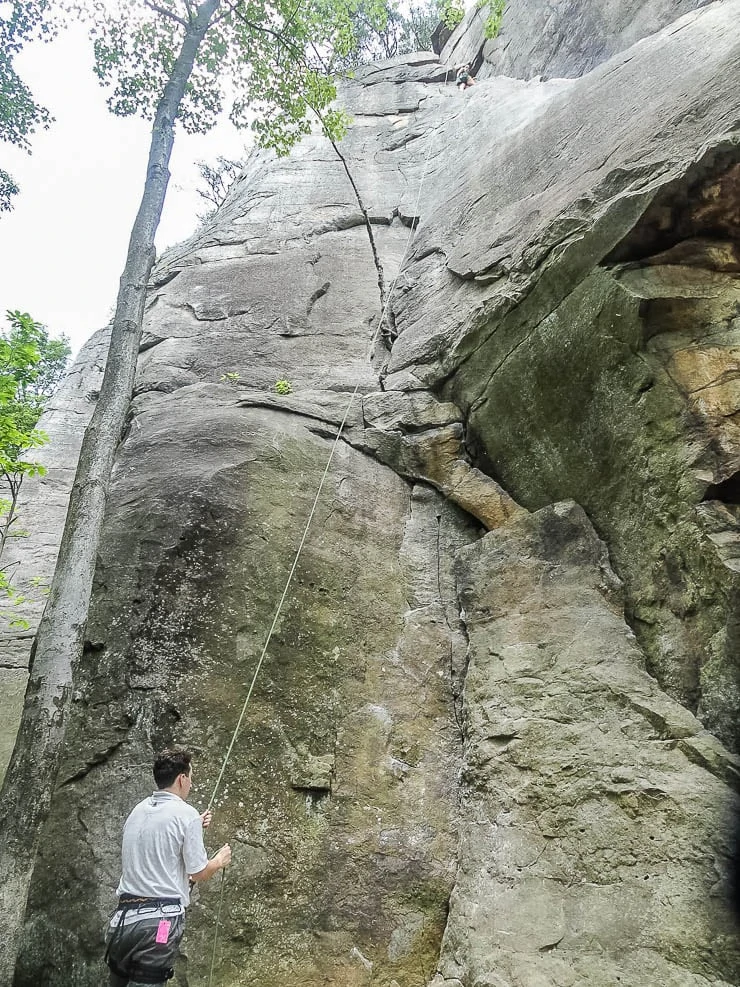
[77, 0, 386, 154]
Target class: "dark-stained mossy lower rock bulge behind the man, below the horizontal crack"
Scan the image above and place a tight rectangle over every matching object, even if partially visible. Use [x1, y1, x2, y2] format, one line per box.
[21, 412, 470, 984]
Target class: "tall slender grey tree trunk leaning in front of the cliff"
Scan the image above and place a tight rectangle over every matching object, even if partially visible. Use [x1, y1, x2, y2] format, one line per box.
[0, 0, 222, 987]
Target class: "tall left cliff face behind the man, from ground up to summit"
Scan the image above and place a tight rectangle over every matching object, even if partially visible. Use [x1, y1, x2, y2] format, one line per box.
[18, 59, 480, 987]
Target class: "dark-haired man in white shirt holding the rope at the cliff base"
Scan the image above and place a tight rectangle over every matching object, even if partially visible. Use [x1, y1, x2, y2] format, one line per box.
[105, 750, 231, 987]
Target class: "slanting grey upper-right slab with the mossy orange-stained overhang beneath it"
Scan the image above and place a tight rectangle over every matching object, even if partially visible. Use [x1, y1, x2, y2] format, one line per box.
[389, 2, 740, 744]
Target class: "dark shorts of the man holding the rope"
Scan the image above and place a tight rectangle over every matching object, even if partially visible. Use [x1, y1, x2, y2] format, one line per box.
[105, 915, 185, 987]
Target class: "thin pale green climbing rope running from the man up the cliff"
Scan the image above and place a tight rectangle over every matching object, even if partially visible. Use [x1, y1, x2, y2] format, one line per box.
[202, 70, 442, 987]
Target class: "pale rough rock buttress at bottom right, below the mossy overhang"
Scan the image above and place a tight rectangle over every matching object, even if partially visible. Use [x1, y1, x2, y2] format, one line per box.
[433, 503, 737, 987]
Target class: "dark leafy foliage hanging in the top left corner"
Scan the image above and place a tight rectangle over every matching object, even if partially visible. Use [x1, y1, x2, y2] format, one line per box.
[0, 0, 52, 212]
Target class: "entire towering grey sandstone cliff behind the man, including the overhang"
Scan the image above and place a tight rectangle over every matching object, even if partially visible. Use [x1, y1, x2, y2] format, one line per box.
[5, 0, 740, 987]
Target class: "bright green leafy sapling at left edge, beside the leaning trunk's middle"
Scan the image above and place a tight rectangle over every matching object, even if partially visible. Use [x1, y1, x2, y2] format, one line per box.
[0, 311, 70, 629]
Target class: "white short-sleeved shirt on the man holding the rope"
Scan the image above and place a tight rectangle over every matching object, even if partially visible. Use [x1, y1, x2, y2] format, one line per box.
[117, 792, 208, 917]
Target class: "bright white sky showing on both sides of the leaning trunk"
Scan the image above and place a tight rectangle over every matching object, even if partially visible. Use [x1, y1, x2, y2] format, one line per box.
[0, 19, 250, 352]
